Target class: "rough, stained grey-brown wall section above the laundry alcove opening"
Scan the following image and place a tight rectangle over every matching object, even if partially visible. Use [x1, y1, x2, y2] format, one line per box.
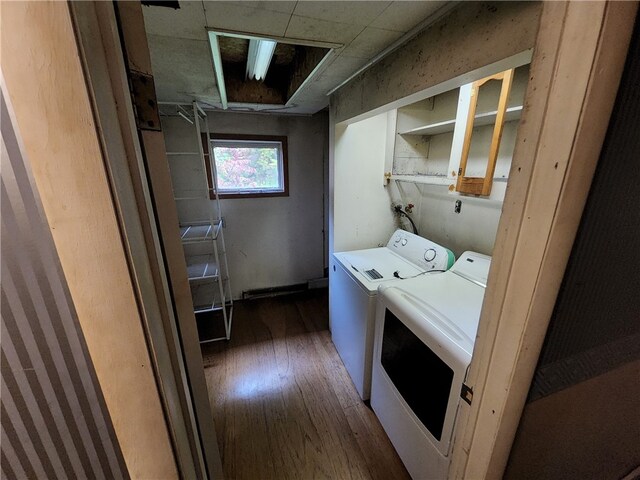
[331, 2, 541, 123]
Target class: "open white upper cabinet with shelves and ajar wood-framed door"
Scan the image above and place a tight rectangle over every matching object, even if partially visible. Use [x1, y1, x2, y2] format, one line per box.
[391, 65, 529, 196]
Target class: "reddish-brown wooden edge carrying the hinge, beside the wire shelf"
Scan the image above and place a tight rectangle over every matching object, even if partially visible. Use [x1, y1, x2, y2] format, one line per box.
[112, 1, 223, 479]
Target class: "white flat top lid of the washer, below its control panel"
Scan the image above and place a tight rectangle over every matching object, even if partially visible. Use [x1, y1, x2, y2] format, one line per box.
[334, 247, 422, 295]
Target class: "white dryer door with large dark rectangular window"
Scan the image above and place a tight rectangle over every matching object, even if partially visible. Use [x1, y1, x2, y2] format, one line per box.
[372, 284, 471, 456]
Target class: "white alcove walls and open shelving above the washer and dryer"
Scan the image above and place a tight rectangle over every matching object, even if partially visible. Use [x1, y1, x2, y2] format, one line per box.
[334, 61, 530, 256]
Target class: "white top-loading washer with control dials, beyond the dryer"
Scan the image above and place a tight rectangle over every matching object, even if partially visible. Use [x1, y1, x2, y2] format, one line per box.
[329, 230, 454, 400]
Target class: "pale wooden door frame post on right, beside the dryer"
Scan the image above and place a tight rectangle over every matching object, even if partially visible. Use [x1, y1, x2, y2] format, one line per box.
[449, 2, 637, 479]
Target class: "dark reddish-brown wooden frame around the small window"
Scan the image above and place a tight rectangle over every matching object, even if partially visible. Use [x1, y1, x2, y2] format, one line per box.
[202, 133, 289, 200]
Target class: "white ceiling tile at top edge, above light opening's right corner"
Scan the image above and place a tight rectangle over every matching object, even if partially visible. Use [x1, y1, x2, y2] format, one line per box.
[293, 1, 391, 26]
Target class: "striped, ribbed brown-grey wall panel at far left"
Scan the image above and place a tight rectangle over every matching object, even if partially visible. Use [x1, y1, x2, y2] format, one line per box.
[0, 94, 129, 479]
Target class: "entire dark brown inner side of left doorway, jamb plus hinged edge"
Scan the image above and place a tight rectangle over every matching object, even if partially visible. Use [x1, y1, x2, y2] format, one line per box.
[69, 2, 223, 479]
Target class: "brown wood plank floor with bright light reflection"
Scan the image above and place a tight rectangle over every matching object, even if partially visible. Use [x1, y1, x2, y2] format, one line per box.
[203, 290, 409, 480]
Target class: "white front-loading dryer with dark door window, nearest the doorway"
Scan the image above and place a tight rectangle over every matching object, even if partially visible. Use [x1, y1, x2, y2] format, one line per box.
[371, 252, 491, 480]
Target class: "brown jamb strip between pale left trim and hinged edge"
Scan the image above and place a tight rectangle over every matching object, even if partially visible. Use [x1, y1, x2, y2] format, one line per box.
[69, 2, 202, 478]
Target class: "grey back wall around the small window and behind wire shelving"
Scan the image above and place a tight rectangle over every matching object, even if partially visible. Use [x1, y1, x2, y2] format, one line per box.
[162, 112, 328, 298]
